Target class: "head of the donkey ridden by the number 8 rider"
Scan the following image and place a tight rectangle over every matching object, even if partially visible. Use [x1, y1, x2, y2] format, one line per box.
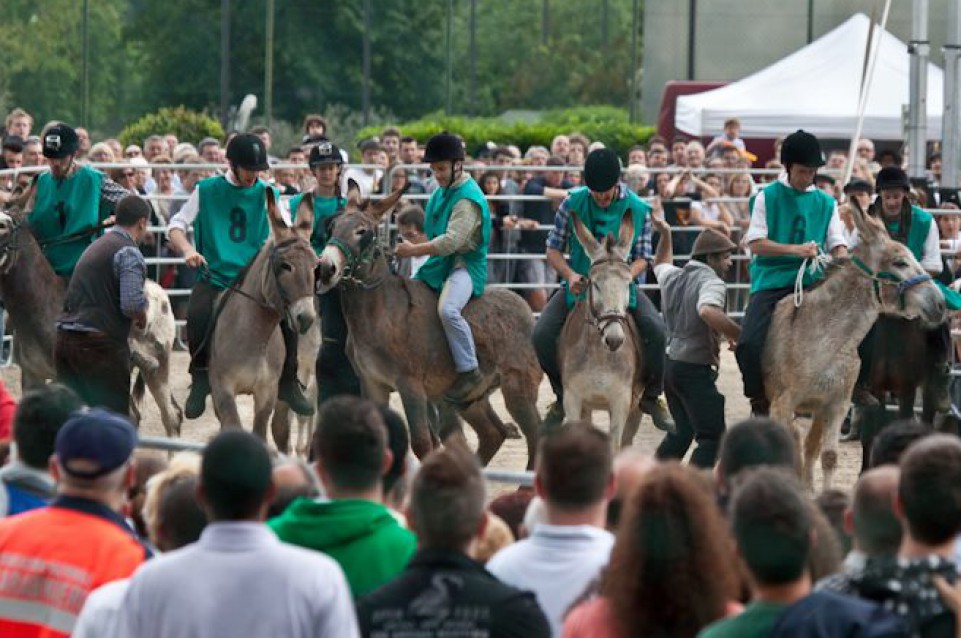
[265, 188, 317, 333]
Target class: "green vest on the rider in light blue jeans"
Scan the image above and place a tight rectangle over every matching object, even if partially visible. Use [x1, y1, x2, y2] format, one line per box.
[414, 177, 491, 297]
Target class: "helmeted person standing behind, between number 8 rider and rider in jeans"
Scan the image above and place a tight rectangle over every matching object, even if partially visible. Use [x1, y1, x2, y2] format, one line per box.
[290, 138, 360, 406]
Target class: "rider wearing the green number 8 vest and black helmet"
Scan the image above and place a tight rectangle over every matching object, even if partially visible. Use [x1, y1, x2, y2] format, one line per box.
[167, 134, 314, 419]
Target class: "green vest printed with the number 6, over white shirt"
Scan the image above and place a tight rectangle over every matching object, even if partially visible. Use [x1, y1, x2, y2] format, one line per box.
[750, 182, 834, 293]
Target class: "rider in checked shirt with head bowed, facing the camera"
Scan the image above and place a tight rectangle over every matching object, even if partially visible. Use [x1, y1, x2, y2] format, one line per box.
[531, 148, 674, 431]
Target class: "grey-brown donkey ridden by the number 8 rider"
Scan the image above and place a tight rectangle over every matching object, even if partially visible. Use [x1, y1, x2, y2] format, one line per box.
[208, 188, 317, 454]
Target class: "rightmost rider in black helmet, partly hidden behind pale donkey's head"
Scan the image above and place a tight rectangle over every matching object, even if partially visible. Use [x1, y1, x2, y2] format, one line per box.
[858, 166, 951, 412]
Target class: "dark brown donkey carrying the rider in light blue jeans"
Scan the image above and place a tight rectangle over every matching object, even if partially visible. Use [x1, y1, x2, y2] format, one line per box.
[316, 190, 543, 468]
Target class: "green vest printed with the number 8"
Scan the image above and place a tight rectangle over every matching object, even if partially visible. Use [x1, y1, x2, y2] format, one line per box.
[194, 175, 272, 289]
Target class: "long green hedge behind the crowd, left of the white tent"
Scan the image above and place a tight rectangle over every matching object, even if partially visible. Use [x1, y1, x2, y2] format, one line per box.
[357, 106, 654, 155]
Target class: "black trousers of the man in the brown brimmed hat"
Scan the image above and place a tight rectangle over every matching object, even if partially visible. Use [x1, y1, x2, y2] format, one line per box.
[655, 359, 724, 468]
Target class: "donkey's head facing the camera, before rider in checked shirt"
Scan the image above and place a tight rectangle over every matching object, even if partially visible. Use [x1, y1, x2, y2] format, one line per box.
[571, 210, 634, 352]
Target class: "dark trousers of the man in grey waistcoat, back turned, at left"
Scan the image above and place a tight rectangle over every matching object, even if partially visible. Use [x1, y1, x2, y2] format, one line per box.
[54, 330, 130, 416]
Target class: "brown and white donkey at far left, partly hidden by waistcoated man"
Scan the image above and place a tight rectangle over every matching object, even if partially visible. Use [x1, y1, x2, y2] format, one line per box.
[0, 183, 183, 437]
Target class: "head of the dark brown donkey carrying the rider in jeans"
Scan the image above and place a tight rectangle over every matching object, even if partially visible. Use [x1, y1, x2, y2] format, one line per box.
[317, 180, 407, 292]
